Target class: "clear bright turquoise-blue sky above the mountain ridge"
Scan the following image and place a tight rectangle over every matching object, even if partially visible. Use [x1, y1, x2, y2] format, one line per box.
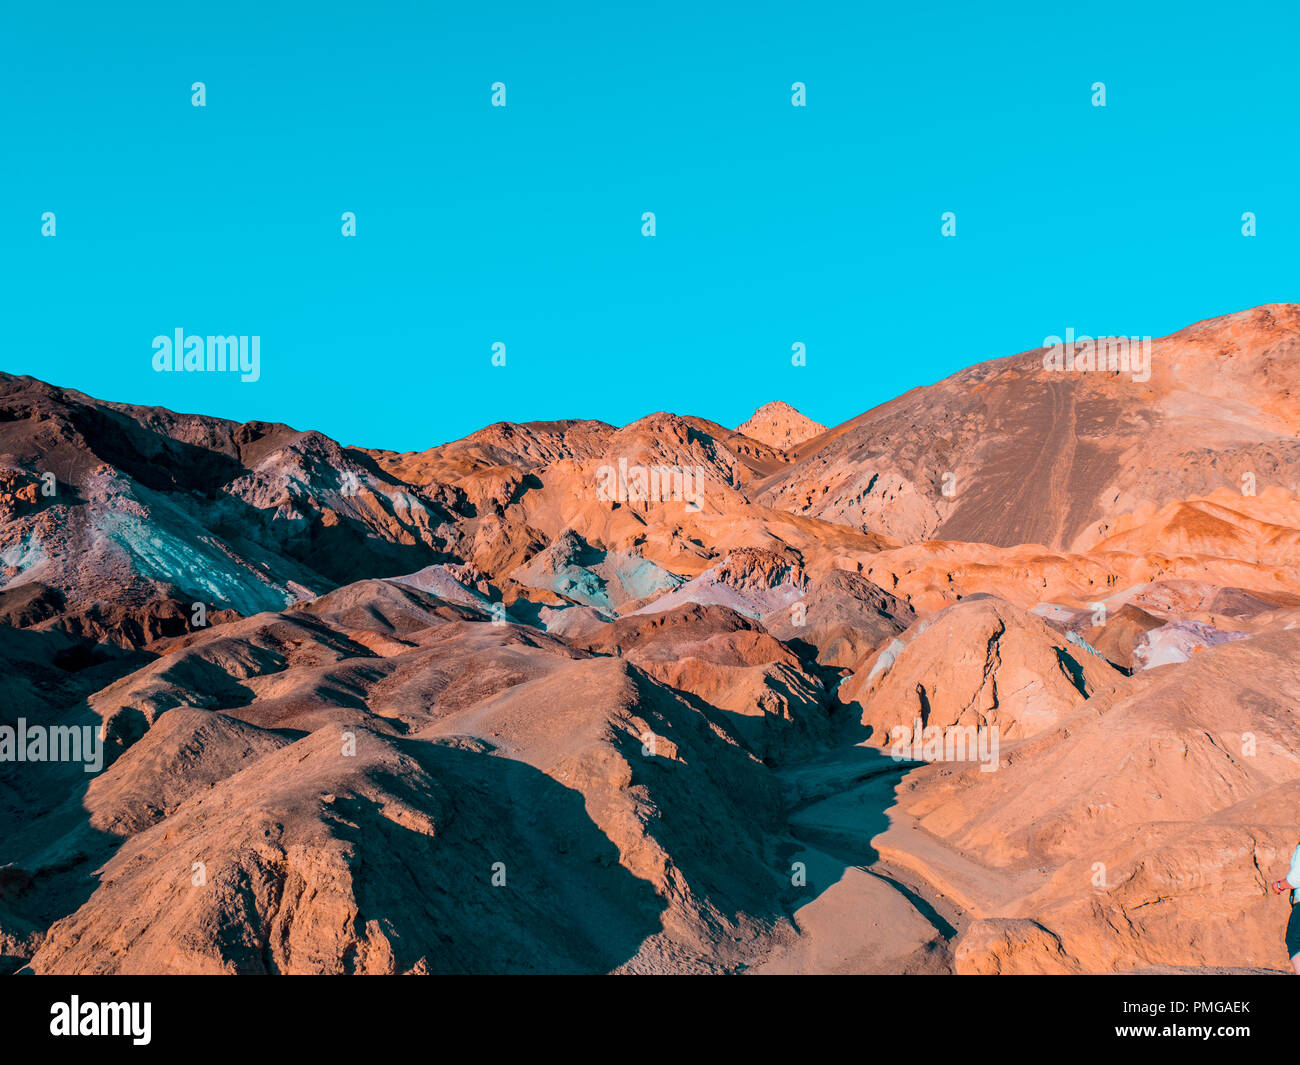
[0, 0, 1300, 450]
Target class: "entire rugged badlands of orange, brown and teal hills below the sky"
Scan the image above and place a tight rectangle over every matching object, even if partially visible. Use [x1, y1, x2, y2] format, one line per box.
[0, 304, 1300, 974]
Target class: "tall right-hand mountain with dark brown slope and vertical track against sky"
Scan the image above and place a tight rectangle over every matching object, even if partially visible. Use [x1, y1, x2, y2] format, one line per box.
[758, 304, 1300, 549]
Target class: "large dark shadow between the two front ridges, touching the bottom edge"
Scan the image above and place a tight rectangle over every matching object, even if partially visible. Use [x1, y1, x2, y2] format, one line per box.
[325, 740, 664, 973]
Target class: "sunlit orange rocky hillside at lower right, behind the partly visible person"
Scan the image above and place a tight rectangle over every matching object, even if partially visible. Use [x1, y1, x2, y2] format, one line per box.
[902, 631, 1300, 973]
